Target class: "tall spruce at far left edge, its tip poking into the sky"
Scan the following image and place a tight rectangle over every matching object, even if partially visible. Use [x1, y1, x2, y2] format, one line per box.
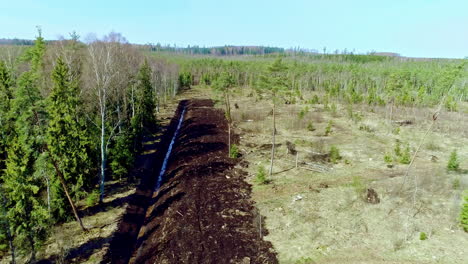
[3, 32, 49, 261]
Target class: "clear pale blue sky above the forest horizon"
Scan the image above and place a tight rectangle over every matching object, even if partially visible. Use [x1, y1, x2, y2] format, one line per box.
[0, 0, 468, 58]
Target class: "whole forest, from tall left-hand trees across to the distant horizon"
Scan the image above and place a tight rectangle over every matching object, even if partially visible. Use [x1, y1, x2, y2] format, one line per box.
[0, 30, 468, 261]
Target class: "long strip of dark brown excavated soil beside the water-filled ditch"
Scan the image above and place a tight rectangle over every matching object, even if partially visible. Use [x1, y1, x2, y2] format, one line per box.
[107, 99, 278, 263]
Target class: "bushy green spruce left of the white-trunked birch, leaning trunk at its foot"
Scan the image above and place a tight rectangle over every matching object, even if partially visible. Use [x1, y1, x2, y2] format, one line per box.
[46, 58, 91, 230]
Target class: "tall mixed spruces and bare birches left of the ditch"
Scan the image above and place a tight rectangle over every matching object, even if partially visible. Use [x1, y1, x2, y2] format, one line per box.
[0, 30, 180, 262]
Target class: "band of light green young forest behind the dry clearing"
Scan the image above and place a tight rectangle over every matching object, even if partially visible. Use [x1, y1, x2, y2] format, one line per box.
[167, 54, 468, 111]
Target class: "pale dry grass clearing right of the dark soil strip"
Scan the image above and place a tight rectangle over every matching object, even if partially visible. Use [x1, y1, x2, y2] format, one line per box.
[220, 87, 468, 263]
